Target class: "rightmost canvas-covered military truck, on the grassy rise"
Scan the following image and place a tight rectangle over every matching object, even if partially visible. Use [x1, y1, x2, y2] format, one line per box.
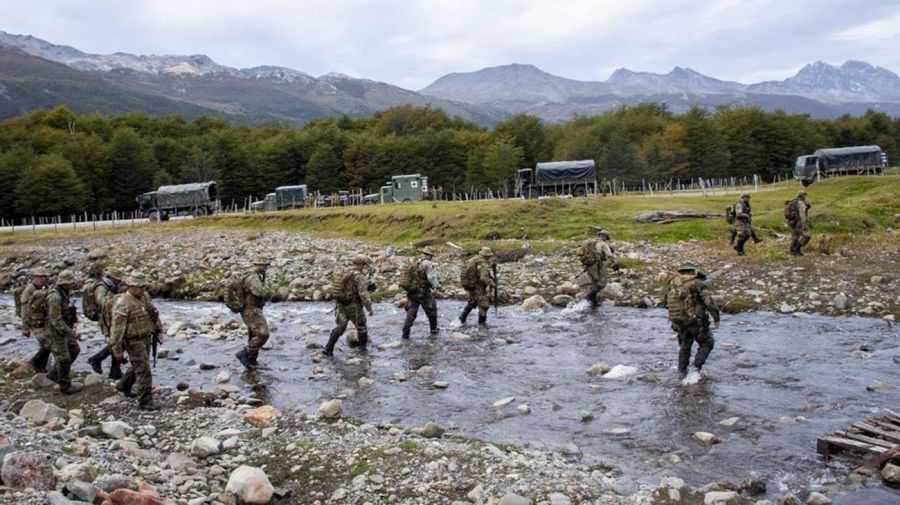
[794, 146, 887, 186]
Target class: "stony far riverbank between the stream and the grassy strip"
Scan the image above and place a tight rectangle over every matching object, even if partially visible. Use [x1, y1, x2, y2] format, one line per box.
[0, 230, 900, 320]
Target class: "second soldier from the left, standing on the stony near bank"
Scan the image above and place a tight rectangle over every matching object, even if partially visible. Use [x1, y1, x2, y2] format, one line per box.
[44, 270, 84, 395]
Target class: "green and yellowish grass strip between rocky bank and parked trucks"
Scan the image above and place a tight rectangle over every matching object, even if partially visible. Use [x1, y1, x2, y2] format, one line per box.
[0, 175, 900, 249]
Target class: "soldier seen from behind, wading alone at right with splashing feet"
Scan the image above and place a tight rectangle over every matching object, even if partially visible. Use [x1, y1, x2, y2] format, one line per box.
[663, 261, 719, 377]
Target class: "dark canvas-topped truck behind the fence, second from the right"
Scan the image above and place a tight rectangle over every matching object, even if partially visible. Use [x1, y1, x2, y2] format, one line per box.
[516, 160, 597, 198]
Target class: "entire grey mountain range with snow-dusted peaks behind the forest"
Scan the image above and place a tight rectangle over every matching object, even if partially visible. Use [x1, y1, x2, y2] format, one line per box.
[0, 31, 900, 125]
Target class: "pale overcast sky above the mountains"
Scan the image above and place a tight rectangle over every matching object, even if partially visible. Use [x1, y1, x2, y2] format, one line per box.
[0, 0, 900, 89]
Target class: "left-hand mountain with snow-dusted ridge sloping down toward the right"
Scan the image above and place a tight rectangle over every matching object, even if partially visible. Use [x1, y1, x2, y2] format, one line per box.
[0, 31, 508, 125]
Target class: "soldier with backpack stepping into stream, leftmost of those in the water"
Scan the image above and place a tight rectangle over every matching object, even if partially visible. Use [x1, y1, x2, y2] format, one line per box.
[234, 256, 271, 370]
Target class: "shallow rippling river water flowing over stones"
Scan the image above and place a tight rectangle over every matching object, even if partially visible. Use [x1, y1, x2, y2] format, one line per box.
[0, 295, 900, 503]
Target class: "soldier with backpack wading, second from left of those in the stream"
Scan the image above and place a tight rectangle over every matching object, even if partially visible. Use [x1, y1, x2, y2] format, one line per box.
[322, 256, 373, 356]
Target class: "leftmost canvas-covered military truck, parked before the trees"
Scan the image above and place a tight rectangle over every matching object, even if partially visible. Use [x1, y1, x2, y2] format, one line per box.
[137, 181, 218, 222]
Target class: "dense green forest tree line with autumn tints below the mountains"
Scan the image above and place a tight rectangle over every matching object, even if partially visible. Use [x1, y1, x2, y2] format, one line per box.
[0, 104, 900, 220]
